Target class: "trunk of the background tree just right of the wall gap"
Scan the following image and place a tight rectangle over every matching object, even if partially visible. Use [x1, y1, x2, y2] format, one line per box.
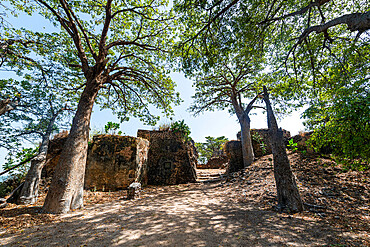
[239, 113, 254, 168]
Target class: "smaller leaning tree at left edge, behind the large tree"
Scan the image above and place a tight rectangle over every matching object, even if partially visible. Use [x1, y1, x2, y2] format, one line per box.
[0, 78, 74, 204]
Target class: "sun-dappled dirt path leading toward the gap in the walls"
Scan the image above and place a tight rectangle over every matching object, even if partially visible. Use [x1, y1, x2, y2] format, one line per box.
[0, 183, 364, 247]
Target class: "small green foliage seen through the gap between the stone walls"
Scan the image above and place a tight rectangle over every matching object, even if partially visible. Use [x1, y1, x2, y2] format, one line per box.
[195, 136, 229, 164]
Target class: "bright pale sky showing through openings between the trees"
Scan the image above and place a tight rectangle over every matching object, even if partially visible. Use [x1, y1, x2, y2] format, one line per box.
[0, 2, 304, 171]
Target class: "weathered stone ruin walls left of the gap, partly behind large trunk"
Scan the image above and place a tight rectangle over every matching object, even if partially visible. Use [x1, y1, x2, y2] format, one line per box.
[43, 130, 198, 191]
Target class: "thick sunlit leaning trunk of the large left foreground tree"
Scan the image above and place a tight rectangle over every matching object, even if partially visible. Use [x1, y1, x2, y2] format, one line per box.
[43, 80, 100, 213]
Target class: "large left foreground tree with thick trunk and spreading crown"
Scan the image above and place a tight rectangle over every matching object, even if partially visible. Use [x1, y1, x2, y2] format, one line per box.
[10, 0, 178, 213]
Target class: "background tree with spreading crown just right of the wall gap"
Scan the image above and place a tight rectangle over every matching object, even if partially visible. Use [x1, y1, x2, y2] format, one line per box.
[190, 51, 260, 167]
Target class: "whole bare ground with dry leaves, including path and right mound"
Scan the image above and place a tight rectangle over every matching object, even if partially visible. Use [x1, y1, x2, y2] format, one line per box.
[0, 154, 370, 246]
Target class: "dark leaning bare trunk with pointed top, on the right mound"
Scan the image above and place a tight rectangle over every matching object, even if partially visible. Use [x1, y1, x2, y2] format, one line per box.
[263, 87, 303, 213]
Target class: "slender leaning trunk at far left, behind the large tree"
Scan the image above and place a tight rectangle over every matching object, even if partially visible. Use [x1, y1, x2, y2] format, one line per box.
[16, 111, 60, 204]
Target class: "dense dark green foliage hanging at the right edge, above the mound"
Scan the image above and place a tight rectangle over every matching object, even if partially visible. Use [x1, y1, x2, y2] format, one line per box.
[304, 82, 370, 163]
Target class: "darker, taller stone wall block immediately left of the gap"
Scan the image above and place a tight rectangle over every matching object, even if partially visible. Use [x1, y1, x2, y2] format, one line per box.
[137, 130, 197, 185]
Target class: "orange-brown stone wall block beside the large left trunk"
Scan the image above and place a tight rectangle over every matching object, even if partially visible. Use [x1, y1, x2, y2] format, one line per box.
[85, 135, 149, 191]
